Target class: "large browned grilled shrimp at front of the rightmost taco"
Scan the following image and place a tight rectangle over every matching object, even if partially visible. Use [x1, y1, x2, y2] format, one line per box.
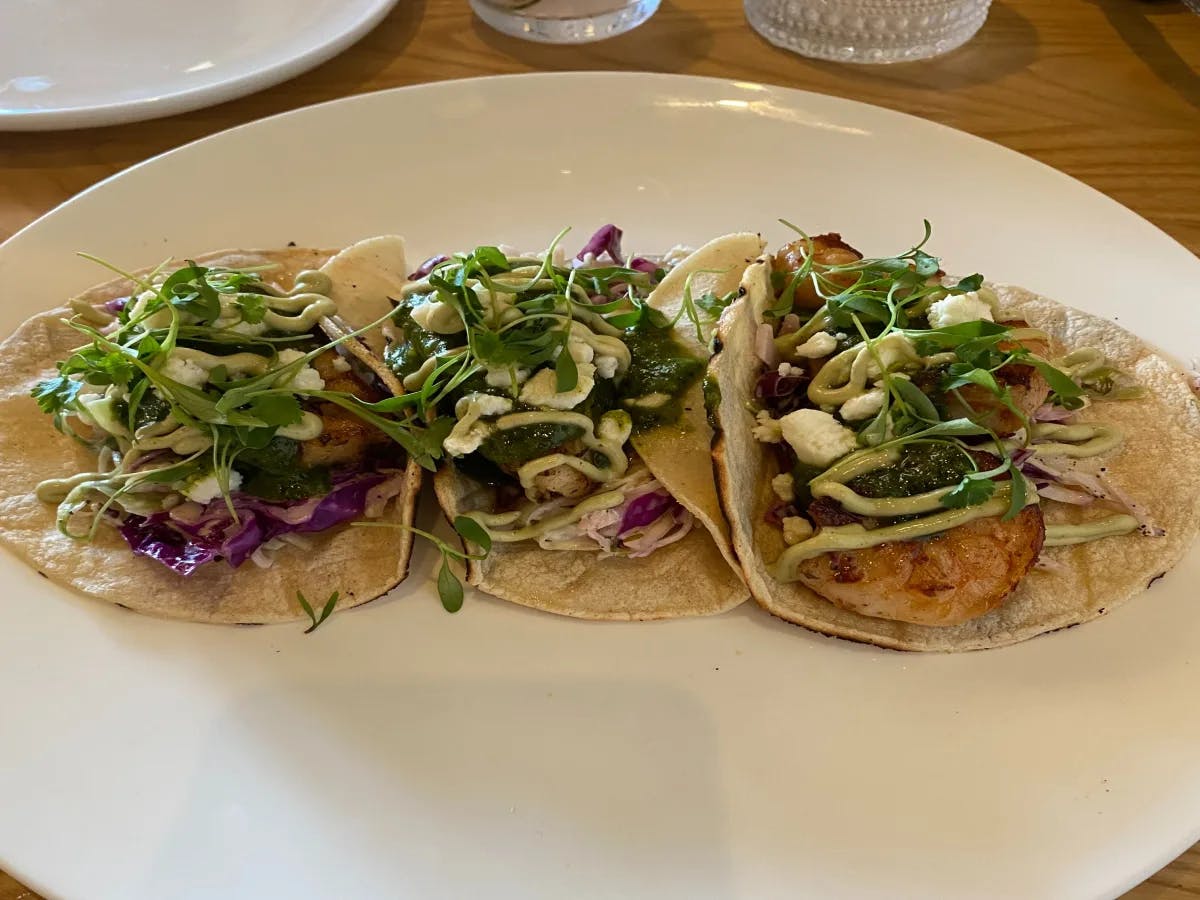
[799, 505, 1045, 625]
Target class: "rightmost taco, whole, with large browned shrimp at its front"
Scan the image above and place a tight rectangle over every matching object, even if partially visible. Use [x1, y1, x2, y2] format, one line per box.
[709, 224, 1200, 650]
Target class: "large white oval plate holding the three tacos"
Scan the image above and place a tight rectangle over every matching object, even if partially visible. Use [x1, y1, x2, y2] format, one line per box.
[0, 74, 1200, 900]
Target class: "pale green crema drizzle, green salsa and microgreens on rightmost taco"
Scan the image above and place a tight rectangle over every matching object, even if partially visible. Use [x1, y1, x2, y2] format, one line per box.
[756, 222, 1141, 581]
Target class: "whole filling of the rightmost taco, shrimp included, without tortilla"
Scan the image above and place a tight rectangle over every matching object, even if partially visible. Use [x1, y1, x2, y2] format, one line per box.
[750, 233, 1159, 626]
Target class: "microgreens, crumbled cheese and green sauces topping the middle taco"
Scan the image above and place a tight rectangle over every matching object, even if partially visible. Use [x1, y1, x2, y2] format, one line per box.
[385, 230, 733, 548]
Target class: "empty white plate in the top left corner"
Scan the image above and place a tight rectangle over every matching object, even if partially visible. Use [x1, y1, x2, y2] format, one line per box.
[0, 0, 396, 131]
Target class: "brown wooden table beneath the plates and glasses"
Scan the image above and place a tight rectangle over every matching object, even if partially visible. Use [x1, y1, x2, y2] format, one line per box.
[0, 0, 1200, 900]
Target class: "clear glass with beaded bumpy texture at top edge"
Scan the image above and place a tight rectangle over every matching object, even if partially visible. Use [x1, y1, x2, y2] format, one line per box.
[745, 0, 991, 62]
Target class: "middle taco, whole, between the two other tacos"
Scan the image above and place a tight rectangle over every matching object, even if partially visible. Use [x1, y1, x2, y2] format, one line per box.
[385, 226, 762, 619]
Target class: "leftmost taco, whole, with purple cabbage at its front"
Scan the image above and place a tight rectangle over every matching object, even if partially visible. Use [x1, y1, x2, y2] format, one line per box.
[0, 238, 433, 623]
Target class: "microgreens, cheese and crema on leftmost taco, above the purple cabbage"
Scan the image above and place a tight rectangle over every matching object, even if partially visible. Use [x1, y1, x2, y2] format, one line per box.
[32, 257, 440, 547]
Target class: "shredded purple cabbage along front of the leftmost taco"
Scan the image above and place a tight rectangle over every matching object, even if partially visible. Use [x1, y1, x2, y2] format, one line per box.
[120, 472, 388, 575]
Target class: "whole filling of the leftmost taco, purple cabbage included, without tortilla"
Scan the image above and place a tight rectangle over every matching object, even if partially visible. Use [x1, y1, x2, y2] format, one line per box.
[32, 250, 436, 576]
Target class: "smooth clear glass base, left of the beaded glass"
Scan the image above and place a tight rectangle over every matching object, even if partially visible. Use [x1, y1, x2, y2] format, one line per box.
[470, 0, 660, 43]
